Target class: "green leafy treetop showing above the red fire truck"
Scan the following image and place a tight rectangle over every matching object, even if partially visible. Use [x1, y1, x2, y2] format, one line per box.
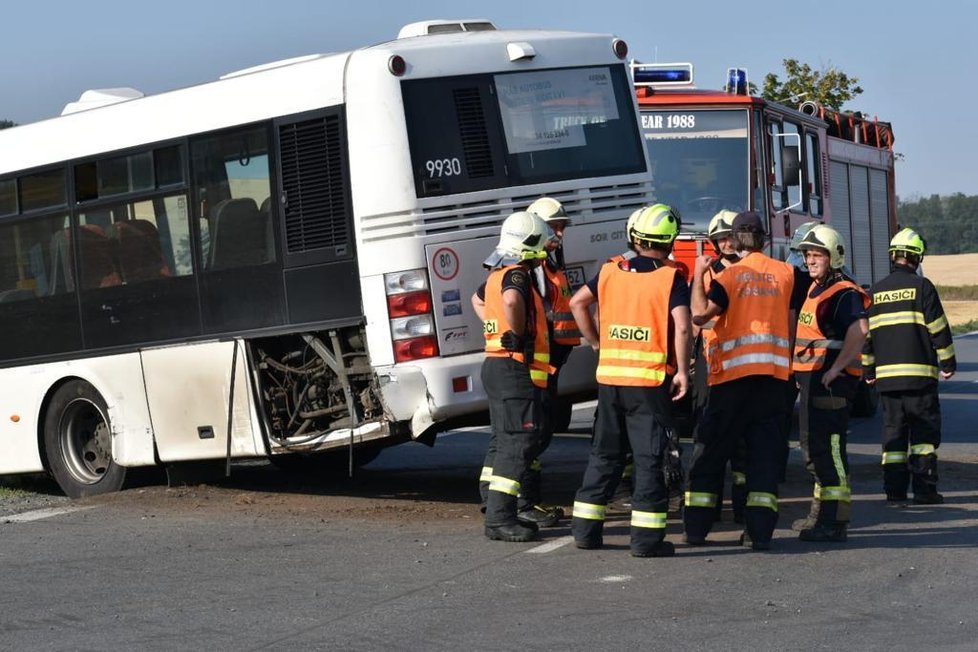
[761, 59, 863, 111]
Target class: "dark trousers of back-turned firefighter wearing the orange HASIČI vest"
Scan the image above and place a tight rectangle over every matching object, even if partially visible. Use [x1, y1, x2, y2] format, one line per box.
[571, 378, 671, 552]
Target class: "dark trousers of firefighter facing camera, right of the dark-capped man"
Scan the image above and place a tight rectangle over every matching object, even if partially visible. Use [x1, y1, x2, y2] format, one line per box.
[795, 370, 861, 525]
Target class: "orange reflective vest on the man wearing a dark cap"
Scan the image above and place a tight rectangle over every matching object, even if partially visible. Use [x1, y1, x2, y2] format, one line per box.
[706, 252, 795, 386]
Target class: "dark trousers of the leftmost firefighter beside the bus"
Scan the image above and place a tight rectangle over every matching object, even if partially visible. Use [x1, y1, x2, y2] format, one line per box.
[482, 357, 546, 527]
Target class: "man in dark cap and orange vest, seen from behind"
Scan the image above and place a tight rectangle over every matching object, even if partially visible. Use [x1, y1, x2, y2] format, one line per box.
[683, 211, 794, 550]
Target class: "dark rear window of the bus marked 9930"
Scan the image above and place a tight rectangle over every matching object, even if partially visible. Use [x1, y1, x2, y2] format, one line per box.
[402, 65, 645, 197]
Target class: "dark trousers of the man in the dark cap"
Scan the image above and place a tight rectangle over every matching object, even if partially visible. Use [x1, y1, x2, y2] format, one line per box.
[683, 376, 785, 543]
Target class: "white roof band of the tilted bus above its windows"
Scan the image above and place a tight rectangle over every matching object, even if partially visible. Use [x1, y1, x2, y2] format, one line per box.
[0, 30, 619, 175]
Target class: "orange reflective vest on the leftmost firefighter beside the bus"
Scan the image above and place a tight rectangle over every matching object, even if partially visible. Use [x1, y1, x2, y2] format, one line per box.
[482, 265, 554, 388]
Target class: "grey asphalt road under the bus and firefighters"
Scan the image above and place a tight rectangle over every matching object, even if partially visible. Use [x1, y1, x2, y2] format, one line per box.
[0, 337, 978, 650]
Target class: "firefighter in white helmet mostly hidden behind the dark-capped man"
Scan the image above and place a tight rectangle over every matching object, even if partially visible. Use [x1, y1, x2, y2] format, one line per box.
[693, 210, 747, 523]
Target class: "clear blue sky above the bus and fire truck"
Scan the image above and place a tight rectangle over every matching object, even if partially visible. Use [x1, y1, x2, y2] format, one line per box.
[0, 0, 978, 199]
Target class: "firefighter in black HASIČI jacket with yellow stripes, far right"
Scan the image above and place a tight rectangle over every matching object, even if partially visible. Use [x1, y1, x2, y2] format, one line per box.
[863, 229, 957, 505]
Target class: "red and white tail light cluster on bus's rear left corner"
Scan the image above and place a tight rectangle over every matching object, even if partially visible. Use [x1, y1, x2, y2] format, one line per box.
[384, 269, 438, 362]
